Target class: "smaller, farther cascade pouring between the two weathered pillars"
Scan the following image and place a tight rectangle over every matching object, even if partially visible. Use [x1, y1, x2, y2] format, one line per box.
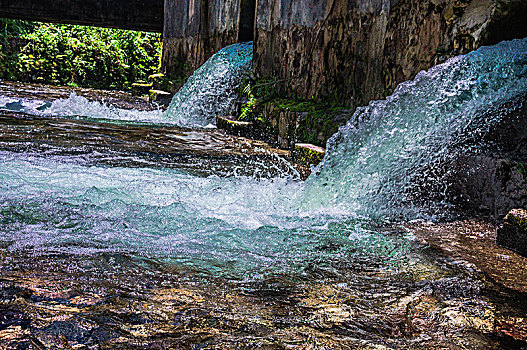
[165, 42, 253, 126]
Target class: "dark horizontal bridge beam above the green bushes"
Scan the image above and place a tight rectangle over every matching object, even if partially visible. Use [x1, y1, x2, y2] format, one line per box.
[0, 0, 164, 33]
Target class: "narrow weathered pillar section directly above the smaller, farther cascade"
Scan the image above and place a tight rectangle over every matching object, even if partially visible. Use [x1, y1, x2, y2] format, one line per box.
[163, 0, 255, 76]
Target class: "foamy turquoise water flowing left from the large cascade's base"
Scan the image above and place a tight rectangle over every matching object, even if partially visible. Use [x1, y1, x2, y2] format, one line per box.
[0, 152, 407, 278]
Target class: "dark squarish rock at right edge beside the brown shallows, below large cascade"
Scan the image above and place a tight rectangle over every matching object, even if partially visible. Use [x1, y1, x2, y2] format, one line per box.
[496, 209, 527, 257]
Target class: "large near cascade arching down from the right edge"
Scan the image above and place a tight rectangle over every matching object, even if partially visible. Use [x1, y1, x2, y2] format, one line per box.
[303, 39, 527, 218]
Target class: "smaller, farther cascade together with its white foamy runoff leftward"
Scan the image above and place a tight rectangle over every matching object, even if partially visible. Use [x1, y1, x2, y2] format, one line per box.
[0, 42, 253, 127]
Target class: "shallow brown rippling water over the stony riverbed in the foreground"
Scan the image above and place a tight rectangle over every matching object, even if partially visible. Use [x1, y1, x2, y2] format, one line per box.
[0, 221, 527, 349]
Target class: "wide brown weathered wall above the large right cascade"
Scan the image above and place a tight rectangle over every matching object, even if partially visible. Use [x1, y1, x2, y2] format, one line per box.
[255, 0, 527, 106]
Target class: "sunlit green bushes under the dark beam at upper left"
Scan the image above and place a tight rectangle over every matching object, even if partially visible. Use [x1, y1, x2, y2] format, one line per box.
[0, 19, 162, 90]
